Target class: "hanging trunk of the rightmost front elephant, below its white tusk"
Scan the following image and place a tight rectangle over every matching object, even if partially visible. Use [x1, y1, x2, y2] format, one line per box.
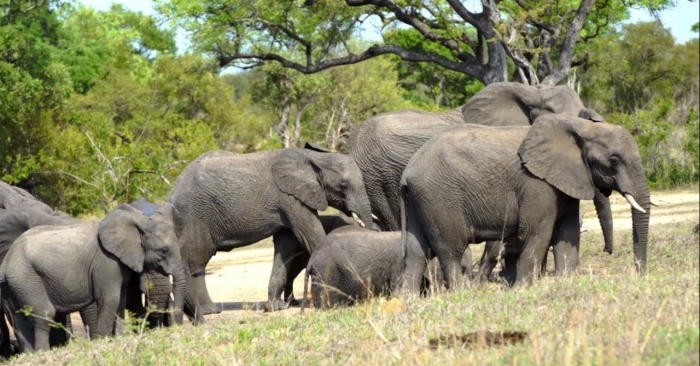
[632, 169, 651, 275]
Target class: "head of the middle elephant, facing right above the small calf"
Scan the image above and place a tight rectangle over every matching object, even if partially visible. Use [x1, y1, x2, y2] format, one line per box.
[272, 149, 372, 227]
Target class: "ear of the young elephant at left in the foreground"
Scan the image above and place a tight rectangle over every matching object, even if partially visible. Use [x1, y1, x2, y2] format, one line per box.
[97, 204, 148, 273]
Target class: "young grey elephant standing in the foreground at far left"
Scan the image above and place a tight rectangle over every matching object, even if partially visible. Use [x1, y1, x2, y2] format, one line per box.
[0, 204, 186, 352]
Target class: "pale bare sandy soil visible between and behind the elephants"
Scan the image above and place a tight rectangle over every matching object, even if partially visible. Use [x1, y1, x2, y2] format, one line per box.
[67, 191, 700, 336]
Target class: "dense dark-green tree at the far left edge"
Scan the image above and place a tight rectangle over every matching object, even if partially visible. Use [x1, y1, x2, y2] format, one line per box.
[0, 0, 72, 182]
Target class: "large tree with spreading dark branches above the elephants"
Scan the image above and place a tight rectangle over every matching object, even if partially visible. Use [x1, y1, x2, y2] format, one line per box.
[158, 0, 669, 84]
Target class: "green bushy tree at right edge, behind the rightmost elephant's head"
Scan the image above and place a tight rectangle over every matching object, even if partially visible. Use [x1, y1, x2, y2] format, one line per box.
[581, 21, 700, 188]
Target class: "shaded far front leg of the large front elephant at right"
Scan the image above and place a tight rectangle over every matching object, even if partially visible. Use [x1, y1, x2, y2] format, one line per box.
[551, 207, 581, 276]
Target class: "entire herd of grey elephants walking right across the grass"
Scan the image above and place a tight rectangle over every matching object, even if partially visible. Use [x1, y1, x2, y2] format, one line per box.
[0, 82, 650, 356]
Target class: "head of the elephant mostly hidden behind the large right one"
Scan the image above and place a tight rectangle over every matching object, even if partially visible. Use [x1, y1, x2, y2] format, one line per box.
[462, 82, 604, 126]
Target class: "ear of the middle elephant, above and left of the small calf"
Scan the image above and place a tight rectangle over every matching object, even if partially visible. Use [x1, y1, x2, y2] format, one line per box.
[272, 149, 328, 211]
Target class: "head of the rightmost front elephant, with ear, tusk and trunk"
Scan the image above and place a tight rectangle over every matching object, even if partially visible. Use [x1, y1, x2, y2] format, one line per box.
[519, 114, 651, 273]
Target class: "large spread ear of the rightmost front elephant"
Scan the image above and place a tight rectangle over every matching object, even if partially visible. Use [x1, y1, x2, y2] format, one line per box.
[518, 114, 596, 200]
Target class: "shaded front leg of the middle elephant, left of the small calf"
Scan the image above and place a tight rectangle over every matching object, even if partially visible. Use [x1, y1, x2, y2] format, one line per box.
[265, 229, 304, 311]
